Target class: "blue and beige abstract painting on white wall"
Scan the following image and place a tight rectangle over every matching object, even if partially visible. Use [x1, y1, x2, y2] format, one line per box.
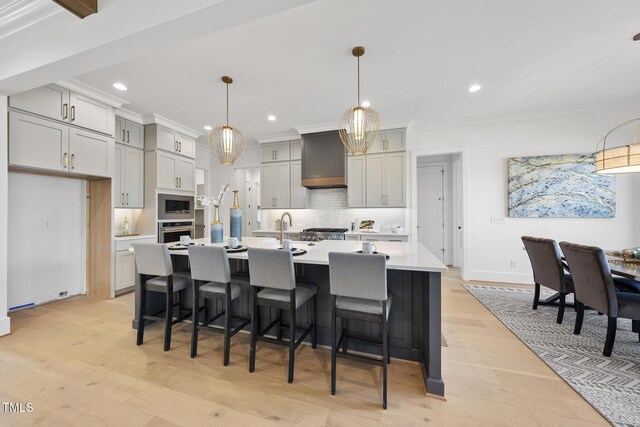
[508, 154, 616, 218]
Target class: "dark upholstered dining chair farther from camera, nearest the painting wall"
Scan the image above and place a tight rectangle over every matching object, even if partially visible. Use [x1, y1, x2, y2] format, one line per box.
[522, 236, 573, 323]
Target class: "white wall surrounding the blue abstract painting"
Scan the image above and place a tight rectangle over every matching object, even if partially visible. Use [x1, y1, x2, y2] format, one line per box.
[407, 106, 640, 283]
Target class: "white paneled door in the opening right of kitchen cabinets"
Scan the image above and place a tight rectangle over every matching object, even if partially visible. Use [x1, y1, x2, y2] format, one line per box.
[417, 165, 445, 262]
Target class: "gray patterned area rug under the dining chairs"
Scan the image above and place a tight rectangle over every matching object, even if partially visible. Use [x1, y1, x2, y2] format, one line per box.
[463, 285, 640, 426]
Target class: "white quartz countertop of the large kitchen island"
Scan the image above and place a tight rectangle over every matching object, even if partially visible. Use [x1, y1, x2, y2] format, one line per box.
[162, 237, 448, 272]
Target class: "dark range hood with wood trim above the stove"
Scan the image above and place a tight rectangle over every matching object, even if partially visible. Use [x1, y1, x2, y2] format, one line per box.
[302, 130, 347, 189]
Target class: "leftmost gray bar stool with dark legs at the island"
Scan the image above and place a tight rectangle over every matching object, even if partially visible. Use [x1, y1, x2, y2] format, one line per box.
[132, 243, 191, 351]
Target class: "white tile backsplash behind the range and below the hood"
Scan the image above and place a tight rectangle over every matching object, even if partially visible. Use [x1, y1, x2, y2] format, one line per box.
[260, 188, 407, 230]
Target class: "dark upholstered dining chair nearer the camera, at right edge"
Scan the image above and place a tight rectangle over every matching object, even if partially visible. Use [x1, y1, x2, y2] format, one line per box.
[560, 242, 640, 357]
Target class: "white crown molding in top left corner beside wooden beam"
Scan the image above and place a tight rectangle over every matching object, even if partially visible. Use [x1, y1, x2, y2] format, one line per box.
[0, 0, 63, 40]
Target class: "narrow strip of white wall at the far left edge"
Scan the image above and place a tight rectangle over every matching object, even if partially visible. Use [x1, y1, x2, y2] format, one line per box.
[0, 96, 10, 336]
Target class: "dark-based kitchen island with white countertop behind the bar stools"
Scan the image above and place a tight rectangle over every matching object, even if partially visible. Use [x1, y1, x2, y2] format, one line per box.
[134, 237, 447, 396]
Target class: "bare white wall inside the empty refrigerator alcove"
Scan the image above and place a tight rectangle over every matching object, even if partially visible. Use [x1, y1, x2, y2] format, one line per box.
[8, 173, 87, 307]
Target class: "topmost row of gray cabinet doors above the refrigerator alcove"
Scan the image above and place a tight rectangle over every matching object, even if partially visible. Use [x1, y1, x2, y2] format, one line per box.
[9, 84, 115, 135]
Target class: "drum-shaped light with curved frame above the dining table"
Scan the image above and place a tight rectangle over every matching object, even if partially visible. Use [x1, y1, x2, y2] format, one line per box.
[596, 117, 640, 174]
